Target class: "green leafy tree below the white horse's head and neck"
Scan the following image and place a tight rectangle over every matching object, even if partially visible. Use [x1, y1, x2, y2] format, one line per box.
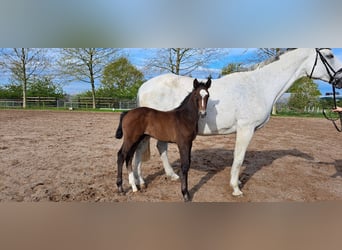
[288, 77, 321, 109]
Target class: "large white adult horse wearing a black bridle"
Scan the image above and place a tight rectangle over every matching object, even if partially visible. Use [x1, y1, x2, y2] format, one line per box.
[134, 48, 342, 196]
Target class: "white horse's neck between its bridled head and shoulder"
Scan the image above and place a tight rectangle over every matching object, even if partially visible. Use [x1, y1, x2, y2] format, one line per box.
[255, 49, 309, 103]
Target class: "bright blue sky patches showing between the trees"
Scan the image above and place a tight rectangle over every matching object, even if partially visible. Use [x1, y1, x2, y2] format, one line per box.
[64, 48, 342, 95]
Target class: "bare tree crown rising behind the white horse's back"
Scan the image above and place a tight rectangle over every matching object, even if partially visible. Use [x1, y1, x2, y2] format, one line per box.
[147, 48, 225, 75]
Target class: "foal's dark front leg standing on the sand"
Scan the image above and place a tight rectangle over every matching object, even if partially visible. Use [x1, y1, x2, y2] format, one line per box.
[178, 141, 192, 202]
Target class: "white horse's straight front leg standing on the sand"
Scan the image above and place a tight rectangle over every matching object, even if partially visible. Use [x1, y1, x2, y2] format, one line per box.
[230, 127, 254, 196]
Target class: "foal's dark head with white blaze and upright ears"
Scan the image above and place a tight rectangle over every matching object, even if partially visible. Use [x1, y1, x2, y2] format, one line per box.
[193, 78, 211, 117]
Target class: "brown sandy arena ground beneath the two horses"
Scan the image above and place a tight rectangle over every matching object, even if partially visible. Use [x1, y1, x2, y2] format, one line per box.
[0, 110, 342, 202]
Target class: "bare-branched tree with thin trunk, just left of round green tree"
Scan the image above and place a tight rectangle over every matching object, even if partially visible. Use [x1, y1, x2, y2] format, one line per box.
[59, 48, 118, 108]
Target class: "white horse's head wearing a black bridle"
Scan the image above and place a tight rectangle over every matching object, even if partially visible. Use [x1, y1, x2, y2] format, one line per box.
[306, 48, 342, 87]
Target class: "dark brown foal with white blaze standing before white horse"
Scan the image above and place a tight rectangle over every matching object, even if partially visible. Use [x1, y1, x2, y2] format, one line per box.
[116, 79, 211, 201]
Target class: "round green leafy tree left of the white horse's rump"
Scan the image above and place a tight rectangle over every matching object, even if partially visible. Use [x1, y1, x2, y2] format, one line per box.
[97, 57, 144, 99]
